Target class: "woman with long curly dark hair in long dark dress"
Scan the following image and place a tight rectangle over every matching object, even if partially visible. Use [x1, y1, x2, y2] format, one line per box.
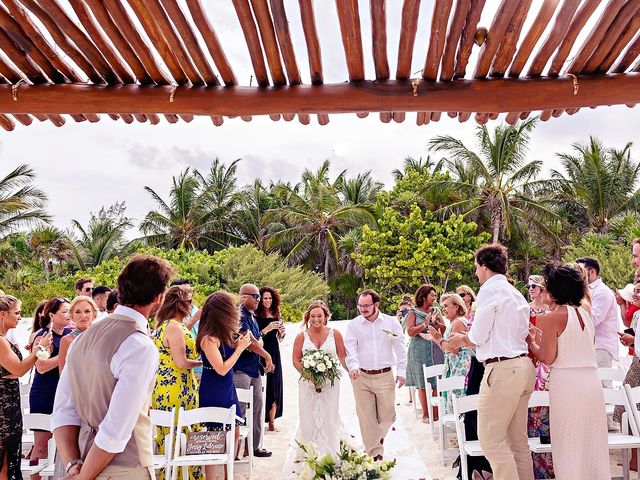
[256, 287, 285, 432]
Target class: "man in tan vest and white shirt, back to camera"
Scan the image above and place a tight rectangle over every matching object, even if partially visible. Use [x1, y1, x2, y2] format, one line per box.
[52, 255, 173, 480]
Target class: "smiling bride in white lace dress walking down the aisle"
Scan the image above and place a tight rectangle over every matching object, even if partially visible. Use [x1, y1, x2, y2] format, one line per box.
[283, 300, 348, 478]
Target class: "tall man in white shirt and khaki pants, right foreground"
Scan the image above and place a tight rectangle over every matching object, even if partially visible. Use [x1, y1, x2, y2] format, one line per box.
[441, 243, 536, 480]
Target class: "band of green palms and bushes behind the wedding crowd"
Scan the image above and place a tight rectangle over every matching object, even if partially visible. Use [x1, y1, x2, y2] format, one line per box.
[0, 119, 640, 320]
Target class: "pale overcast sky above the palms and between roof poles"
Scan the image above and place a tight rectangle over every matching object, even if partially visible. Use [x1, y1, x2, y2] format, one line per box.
[0, 0, 640, 232]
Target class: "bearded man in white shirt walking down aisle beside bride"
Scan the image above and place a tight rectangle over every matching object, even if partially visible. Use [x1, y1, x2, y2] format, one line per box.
[344, 289, 407, 460]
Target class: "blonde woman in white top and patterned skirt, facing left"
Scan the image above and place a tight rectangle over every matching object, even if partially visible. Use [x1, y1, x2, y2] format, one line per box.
[429, 293, 473, 413]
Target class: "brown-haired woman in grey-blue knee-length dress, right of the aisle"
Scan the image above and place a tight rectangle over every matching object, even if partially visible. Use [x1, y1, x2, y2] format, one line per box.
[406, 283, 444, 422]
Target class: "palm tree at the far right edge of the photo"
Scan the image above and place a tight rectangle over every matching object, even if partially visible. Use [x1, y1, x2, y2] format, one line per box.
[549, 137, 640, 233]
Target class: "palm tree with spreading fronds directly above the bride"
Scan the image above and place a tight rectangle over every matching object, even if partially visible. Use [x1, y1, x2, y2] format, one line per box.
[265, 161, 375, 281]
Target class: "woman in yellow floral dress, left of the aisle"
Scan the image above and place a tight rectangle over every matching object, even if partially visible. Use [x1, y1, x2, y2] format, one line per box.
[151, 286, 202, 480]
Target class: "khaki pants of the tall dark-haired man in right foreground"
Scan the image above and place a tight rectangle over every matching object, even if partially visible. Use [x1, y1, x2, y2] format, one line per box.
[478, 357, 536, 480]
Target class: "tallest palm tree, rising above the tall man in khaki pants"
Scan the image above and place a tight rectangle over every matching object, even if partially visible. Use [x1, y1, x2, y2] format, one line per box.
[428, 118, 559, 242]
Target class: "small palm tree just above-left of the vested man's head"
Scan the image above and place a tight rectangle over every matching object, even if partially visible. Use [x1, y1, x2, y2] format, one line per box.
[70, 203, 133, 269]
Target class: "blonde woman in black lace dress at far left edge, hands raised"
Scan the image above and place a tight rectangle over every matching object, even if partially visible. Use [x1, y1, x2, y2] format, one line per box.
[0, 295, 51, 480]
